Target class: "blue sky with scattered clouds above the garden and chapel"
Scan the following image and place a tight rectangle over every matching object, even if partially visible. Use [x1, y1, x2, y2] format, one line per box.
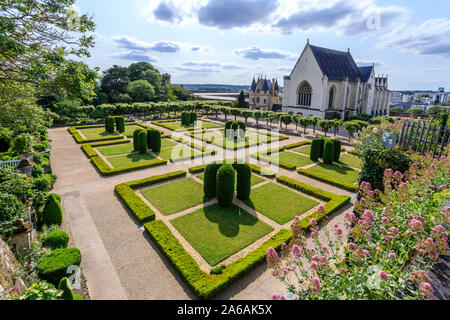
[74, 0, 450, 90]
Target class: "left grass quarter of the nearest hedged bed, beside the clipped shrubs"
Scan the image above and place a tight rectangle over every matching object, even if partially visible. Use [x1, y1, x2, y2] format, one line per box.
[141, 178, 204, 216]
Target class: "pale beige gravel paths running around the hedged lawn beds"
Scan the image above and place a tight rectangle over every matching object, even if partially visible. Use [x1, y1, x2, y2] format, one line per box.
[49, 119, 356, 300]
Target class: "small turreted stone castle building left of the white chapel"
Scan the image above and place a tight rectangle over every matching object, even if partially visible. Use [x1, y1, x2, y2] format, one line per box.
[249, 77, 281, 111]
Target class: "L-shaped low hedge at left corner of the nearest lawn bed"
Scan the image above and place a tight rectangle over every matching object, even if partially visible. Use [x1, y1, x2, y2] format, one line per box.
[114, 171, 186, 223]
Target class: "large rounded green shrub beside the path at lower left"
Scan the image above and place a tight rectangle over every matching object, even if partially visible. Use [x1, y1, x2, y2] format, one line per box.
[37, 248, 81, 285]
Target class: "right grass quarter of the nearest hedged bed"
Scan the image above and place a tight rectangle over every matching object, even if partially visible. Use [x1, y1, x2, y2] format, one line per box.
[245, 183, 319, 225]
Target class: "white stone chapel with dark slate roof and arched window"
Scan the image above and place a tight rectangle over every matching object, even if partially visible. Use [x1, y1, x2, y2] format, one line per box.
[283, 40, 391, 120]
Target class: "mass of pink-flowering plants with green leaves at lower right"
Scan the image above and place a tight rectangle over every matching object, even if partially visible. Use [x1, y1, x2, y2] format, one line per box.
[267, 155, 450, 300]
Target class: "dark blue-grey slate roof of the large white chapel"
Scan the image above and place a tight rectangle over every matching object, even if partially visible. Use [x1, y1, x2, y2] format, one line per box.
[310, 45, 363, 81]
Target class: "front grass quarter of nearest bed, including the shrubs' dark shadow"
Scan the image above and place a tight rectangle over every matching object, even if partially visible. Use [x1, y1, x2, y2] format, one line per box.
[171, 204, 273, 266]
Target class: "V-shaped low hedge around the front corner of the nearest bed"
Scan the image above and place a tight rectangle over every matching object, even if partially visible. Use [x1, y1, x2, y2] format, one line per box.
[145, 220, 292, 299]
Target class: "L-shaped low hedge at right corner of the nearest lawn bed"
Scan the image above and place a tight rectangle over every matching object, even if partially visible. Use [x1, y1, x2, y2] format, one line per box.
[277, 176, 351, 231]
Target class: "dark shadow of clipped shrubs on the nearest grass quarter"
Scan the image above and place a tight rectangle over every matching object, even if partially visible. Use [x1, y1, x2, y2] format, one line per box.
[203, 205, 258, 238]
